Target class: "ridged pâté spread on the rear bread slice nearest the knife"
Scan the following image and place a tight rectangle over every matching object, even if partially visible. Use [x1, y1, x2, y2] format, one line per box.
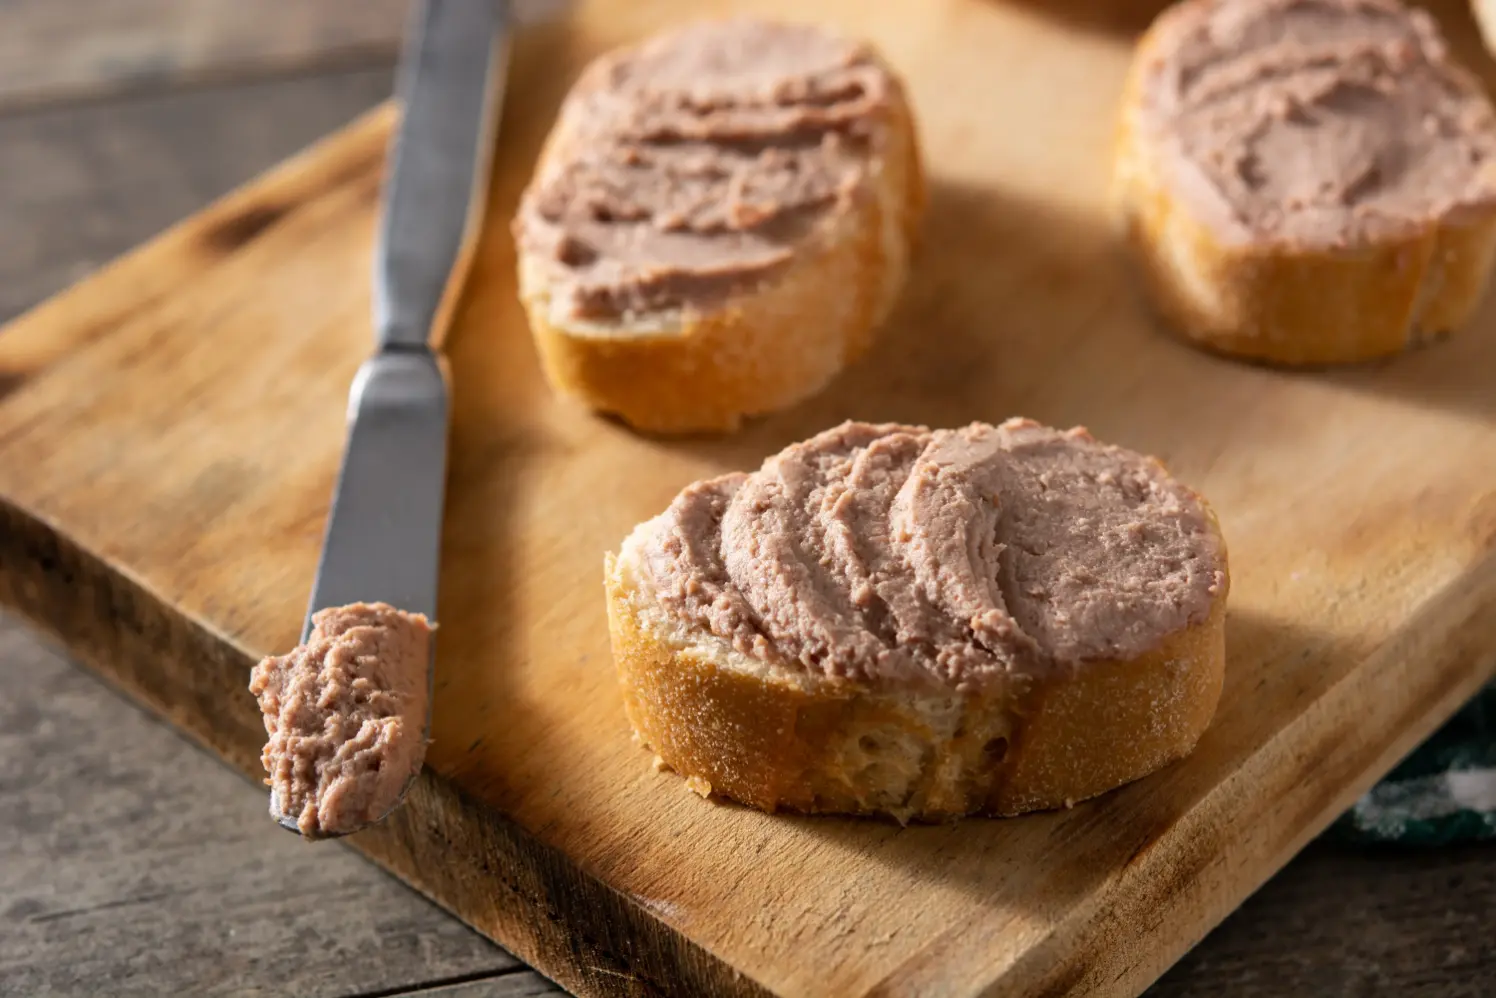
[513, 18, 896, 322]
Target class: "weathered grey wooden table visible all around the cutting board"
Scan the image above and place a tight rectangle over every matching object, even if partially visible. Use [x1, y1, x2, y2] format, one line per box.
[0, 0, 1496, 998]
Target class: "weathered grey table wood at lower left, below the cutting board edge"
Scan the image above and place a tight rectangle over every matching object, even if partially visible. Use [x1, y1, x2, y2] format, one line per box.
[0, 615, 520, 997]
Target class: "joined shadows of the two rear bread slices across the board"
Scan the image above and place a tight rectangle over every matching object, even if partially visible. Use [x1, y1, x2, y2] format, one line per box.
[673, 172, 1496, 499]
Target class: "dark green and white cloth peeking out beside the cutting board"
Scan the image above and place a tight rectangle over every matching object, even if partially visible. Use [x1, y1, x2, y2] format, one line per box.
[1330, 682, 1496, 845]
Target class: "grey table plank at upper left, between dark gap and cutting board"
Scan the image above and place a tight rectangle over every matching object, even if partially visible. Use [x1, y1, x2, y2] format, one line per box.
[0, 66, 392, 320]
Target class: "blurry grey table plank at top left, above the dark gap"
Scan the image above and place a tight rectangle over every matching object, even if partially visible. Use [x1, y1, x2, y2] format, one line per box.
[0, 0, 410, 111]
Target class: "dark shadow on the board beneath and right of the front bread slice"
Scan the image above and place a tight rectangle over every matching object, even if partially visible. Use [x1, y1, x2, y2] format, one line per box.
[784, 609, 1322, 947]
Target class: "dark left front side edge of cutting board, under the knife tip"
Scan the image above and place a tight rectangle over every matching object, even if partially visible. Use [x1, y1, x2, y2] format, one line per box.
[0, 497, 773, 998]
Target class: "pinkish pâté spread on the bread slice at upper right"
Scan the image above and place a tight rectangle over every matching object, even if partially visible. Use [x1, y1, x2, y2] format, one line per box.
[1137, 0, 1496, 247]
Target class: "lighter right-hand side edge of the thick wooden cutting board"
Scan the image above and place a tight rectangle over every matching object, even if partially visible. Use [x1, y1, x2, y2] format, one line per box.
[983, 549, 1496, 998]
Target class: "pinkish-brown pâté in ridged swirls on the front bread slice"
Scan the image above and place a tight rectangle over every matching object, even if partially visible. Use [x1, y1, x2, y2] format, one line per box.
[639, 419, 1227, 691]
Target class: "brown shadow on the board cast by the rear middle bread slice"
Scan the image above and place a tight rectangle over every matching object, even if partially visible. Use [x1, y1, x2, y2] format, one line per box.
[663, 178, 1216, 467]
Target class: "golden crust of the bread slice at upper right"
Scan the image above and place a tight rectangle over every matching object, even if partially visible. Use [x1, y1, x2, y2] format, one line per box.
[1112, 24, 1496, 365]
